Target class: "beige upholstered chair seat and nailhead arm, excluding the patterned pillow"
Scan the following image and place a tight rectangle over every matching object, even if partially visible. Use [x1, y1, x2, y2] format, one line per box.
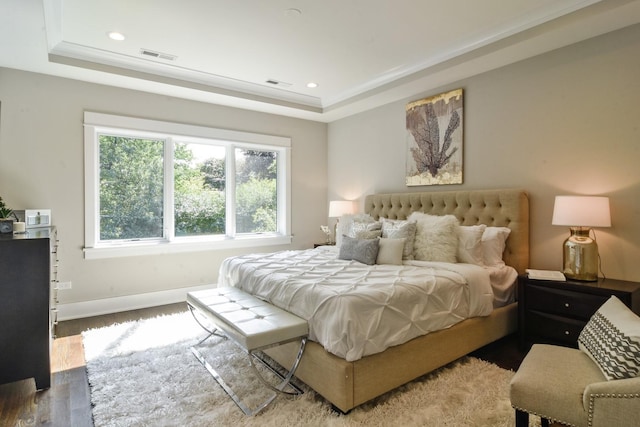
[510, 344, 640, 427]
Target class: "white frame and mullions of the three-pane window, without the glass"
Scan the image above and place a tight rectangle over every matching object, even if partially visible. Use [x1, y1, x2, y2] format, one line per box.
[83, 111, 292, 259]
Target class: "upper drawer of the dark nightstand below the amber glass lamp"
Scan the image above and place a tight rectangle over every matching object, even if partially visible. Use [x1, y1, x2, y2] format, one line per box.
[525, 285, 609, 321]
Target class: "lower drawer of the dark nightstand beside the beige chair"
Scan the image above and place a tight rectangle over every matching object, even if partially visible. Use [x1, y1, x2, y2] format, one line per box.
[526, 311, 587, 347]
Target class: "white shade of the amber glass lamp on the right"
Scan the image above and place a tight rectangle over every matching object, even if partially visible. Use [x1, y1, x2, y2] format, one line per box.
[551, 196, 611, 227]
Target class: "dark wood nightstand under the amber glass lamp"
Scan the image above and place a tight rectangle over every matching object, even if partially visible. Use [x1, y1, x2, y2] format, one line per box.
[518, 275, 640, 350]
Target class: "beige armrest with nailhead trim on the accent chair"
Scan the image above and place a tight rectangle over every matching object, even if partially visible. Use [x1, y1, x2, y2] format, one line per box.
[583, 377, 640, 427]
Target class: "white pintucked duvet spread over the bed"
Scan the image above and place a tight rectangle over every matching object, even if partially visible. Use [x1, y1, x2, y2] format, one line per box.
[218, 249, 494, 361]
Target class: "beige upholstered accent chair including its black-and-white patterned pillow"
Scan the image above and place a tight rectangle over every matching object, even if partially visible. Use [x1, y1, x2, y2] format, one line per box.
[511, 296, 640, 427]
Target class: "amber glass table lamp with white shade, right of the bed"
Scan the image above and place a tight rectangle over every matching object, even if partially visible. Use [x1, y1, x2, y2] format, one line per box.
[551, 196, 611, 282]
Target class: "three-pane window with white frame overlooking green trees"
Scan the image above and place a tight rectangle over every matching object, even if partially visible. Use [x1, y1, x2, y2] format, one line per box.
[84, 112, 291, 258]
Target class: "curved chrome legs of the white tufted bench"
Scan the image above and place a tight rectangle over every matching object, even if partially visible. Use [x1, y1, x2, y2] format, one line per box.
[190, 307, 307, 416]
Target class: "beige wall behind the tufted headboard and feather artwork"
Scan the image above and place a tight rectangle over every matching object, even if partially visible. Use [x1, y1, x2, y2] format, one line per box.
[328, 25, 640, 281]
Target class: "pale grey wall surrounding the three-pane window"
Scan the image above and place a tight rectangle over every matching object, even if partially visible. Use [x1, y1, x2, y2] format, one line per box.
[0, 68, 327, 317]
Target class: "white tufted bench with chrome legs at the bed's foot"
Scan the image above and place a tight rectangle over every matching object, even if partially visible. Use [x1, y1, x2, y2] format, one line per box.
[187, 287, 309, 415]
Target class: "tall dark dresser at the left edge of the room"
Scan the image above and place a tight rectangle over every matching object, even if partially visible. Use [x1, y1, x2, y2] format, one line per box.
[0, 229, 53, 389]
